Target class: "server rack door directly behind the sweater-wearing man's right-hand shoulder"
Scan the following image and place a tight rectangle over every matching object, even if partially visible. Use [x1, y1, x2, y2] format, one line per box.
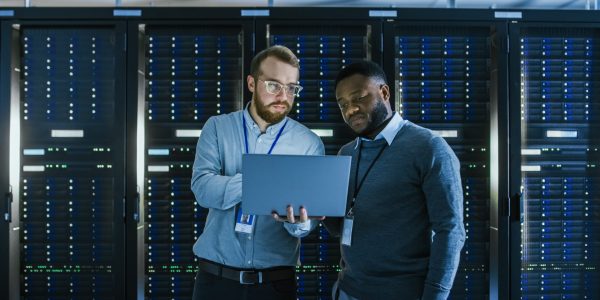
[384, 22, 498, 299]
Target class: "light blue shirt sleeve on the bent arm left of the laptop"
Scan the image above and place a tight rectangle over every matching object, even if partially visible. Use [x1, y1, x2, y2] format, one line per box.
[191, 118, 242, 210]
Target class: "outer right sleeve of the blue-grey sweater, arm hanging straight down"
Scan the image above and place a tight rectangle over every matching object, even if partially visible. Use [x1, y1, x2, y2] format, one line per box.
[422, 137, 465, 300]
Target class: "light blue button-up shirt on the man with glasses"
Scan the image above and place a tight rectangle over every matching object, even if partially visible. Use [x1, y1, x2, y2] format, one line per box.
[191, 108, 325, 269]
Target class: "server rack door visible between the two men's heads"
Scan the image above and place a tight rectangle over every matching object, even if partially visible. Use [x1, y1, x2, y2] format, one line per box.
[257, 20, 379, 299]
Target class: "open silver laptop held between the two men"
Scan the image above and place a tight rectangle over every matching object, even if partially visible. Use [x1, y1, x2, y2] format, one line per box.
[242, 154, 352, 217]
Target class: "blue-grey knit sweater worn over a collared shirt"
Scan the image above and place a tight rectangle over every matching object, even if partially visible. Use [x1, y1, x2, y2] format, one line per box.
[326, 122, 465, 300]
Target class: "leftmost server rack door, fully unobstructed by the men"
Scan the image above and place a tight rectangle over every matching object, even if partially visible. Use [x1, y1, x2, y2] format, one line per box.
[11, 23, 125, 299]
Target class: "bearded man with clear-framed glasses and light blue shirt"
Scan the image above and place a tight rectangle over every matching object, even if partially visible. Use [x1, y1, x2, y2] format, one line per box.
[191, 46, 324, 300]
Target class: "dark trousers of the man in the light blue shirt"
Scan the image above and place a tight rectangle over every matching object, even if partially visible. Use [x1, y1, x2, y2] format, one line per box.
[192, 270, 296, 300]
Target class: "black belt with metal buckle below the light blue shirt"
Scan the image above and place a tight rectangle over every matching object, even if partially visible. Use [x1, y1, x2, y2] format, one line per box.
[199, 260, 296, 284]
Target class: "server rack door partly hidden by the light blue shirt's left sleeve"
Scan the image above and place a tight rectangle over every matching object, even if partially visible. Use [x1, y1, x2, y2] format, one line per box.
[138, 23, 249, 299]
